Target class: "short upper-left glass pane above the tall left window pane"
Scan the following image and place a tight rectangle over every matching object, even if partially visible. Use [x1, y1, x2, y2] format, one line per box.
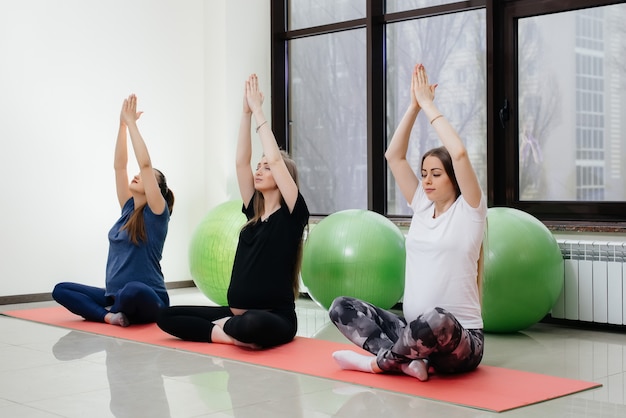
[287, 0, 365, 30]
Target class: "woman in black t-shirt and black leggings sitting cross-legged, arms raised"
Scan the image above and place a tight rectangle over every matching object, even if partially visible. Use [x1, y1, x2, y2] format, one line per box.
[157, 75, 309, 348]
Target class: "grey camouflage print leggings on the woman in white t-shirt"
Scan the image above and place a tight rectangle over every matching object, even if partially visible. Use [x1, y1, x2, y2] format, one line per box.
[329, 297, 484, 373]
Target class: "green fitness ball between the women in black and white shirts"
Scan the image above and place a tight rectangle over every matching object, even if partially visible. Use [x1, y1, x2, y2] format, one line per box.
[301, 209, 405, 309]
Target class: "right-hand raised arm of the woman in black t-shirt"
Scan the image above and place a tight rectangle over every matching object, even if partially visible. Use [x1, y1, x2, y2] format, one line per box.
[246, 74, 298, 211]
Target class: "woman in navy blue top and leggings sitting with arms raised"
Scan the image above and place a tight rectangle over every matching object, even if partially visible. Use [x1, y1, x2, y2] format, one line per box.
[52, 94, 174, 327]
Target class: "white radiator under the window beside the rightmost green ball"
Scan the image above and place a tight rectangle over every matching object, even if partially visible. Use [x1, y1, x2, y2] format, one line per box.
[551, 240, 626, 325]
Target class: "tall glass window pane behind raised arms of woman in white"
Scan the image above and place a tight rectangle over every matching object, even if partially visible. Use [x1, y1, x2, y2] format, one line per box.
[387, 9, 487, 215]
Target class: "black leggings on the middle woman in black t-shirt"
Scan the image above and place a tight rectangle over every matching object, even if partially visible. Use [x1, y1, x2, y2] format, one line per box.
[157, 306, 298, 348]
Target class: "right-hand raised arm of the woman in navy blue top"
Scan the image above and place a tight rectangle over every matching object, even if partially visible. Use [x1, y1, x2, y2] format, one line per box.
[121, 94, 166, 215]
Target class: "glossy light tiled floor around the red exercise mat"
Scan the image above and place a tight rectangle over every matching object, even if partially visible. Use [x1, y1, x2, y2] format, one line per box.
[0, 289, 626, 418]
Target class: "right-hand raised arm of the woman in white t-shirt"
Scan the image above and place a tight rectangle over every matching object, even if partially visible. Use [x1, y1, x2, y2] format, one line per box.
[413, 64, 482, 208]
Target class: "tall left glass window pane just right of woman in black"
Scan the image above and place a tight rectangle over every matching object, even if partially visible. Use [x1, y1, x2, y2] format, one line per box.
[289, 29, 367, 214]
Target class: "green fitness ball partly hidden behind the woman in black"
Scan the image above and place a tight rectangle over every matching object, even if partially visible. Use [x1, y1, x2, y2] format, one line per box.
[189, 200, 246, 306]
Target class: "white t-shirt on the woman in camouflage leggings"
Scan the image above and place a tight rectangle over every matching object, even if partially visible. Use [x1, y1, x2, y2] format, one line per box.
[403, 182, 487, 329]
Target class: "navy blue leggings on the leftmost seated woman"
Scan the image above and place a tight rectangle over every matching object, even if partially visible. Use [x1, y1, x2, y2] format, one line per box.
[52, 282, 169, 324]
